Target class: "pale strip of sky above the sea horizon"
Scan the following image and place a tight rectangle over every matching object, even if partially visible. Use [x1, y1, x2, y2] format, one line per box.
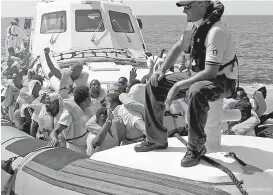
[1, 0, 273, 17]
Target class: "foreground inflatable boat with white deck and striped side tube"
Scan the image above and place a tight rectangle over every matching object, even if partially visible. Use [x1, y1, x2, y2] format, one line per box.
[1, 123, 273, 195]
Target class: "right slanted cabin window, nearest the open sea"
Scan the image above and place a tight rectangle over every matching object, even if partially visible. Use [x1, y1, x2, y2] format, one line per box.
[109, 11, 135, 33]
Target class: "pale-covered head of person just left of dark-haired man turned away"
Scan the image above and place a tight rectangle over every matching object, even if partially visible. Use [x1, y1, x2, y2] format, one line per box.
[41, 92, 63, 116]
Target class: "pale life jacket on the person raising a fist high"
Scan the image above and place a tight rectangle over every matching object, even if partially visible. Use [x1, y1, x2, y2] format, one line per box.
[59, 69, 89, 99]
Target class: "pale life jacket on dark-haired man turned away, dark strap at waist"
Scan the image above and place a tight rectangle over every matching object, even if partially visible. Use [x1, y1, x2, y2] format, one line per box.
[64, 99, 91, 147]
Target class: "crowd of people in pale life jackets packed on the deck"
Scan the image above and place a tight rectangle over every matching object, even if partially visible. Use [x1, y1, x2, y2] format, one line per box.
[1, 43, 272, 156]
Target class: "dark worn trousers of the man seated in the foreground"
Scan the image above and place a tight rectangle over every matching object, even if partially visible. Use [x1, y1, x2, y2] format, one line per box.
[145, 73, 236, 150]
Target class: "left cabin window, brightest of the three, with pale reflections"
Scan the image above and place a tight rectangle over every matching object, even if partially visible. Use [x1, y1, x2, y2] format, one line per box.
[40, 11, 66, 34]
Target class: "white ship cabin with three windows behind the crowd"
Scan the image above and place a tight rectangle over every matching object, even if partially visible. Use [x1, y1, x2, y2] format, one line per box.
[31, 0, 145, 58]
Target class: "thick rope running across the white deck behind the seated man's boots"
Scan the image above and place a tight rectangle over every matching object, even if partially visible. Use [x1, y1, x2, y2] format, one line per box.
[174, 133, 248, 195]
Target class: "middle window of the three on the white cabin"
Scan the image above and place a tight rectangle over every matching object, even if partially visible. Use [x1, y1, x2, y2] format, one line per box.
[75, 10, 105, 32]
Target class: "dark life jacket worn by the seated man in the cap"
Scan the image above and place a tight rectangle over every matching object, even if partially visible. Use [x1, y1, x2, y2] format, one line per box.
[185, 1, 237, 72]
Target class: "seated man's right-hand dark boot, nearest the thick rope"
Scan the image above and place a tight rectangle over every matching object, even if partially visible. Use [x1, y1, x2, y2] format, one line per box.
[181, 146, 207, 167]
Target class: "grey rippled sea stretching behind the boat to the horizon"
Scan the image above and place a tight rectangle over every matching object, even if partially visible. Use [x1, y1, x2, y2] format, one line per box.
[1, 16, 273, 84]
